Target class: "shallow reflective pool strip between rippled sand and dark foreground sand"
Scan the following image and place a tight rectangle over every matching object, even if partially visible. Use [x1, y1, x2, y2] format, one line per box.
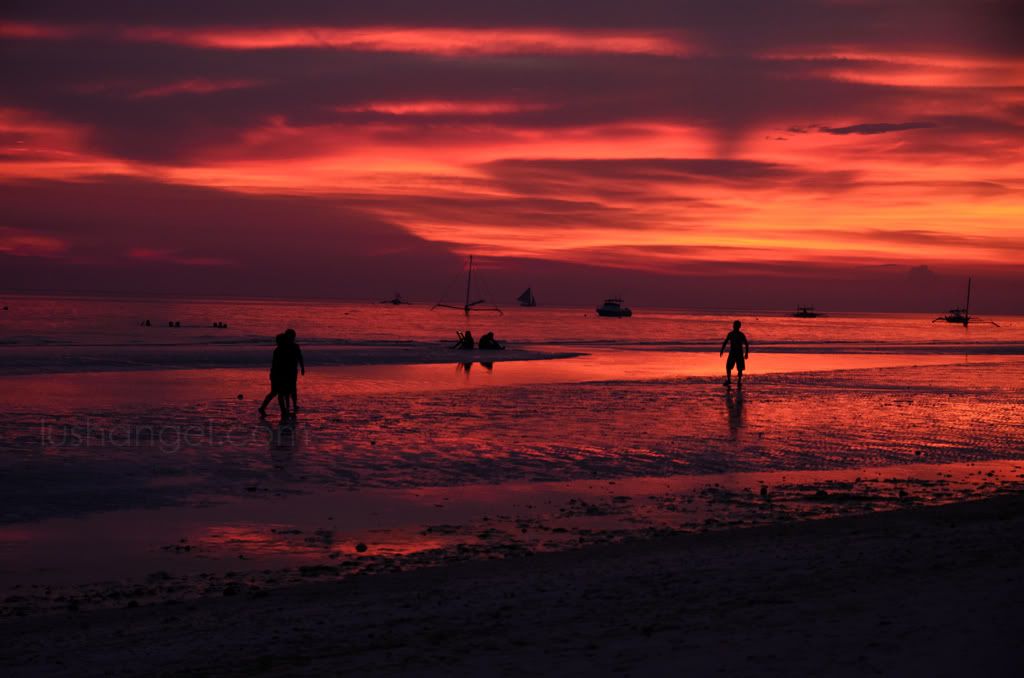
[0, 461, 1024, 591]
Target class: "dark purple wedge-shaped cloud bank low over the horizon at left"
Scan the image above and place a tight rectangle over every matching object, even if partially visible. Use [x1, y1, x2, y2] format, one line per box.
[0, 178, 459, 297]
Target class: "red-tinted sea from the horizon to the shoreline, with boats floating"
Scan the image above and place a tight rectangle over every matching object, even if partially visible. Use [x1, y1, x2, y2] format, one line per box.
[0, 296, 1024, 352]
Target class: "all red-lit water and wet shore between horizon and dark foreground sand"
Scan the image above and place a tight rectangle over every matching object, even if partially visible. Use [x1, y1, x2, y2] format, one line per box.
[0, 298, 1024, 612]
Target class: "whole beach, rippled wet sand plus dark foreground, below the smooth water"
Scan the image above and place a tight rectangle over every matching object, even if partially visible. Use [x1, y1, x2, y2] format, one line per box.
[0, 351, 1024, 675]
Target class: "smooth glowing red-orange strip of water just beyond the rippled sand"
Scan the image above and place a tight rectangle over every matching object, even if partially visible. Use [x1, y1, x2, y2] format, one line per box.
[6, 348, 1015, 413]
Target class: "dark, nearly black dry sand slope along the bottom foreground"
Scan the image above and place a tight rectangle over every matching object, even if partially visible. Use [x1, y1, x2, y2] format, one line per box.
[0, 495, 1024, 676]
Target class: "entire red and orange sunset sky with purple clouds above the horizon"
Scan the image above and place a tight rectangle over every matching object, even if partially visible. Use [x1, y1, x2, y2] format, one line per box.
[0, 0, 1024, 312]
